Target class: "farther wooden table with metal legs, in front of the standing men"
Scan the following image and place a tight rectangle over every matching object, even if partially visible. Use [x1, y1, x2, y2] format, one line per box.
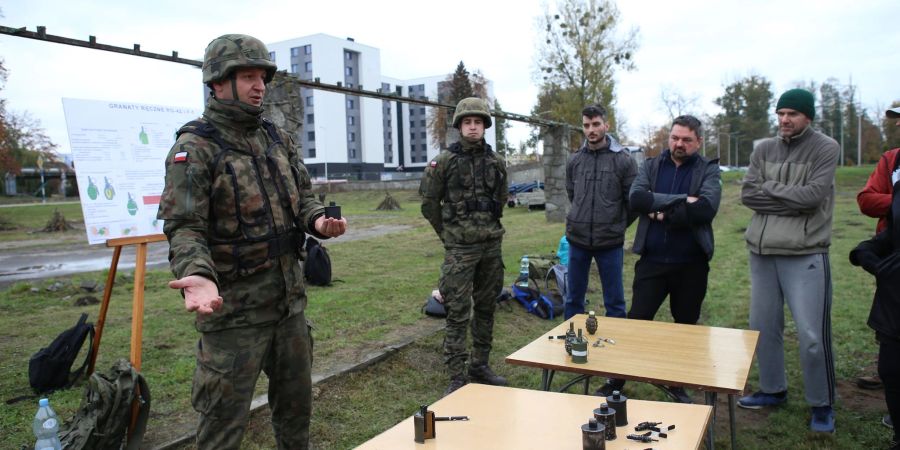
[506, 314, 759, 448]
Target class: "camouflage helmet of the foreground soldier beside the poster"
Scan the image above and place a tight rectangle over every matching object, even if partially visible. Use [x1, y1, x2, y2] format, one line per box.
[203, 34, 278, 86]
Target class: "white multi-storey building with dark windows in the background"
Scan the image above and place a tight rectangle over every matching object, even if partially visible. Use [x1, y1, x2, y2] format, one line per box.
[267, 34, 496, 180]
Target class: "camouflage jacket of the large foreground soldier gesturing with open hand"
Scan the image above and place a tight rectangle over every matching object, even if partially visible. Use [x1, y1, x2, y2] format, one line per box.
[158, 98, 324, 331]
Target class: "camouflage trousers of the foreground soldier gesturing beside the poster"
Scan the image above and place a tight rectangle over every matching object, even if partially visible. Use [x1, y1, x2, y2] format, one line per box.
[191, 312, 313, 450]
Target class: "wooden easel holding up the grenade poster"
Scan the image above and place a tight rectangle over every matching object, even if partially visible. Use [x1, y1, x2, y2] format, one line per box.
[87, 234, 166, 376]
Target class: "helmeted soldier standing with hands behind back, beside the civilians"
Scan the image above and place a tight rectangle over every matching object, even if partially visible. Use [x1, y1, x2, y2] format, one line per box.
[419, 97, 509, 395]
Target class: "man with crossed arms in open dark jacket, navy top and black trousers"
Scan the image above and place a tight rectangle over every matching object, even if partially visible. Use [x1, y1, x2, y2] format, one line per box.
[601, 116, 722, 403]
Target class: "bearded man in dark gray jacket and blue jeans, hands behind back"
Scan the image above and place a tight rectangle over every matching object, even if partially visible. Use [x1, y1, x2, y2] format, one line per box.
[564, 105, 637, 319]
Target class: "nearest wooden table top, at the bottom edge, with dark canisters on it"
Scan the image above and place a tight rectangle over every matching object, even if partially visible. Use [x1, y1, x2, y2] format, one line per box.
[358, 384, 712, 450]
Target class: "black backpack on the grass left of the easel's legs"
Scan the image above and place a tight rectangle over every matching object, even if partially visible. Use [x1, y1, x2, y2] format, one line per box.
[28, 313, 94, 394]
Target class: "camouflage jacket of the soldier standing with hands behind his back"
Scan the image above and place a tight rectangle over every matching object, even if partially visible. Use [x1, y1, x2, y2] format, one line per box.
[419, 141, 509, 245]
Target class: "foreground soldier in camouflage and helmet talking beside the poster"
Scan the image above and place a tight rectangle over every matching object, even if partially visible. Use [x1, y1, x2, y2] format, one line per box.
[158, 34, 347, 449]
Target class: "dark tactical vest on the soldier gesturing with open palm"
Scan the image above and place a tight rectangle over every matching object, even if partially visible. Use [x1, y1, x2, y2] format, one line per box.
[177, 119, 309, 277]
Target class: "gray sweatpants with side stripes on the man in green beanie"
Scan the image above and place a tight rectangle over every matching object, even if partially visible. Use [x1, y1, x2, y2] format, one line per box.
[750, 252, 834, 406]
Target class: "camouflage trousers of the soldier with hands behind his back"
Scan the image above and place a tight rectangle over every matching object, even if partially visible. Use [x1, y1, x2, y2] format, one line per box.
[438, 239, 503, 378]
